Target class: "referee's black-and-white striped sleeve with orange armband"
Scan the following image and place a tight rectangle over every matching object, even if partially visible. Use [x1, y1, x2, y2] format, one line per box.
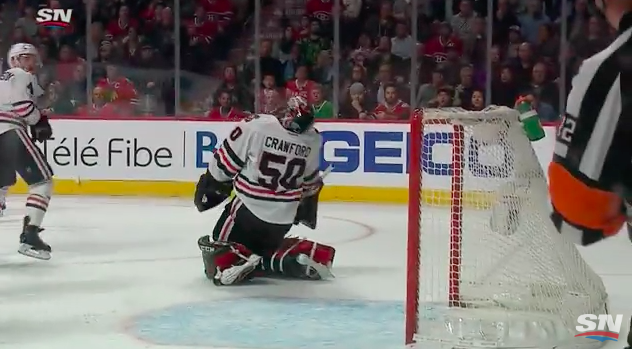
[549, 13, 632, 245]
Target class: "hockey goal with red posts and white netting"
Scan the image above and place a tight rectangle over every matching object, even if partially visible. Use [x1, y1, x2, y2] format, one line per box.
[405, 106, 607, 349]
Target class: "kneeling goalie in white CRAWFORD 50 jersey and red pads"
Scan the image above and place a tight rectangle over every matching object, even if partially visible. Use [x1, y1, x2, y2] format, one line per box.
[195, 97, 335, 285]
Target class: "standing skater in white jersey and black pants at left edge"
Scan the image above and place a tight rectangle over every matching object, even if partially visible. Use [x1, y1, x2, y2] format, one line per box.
[0, 43, 53, 260]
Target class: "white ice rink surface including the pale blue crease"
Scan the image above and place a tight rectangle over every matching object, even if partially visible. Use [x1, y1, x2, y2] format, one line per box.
[0, 197, 632, 349]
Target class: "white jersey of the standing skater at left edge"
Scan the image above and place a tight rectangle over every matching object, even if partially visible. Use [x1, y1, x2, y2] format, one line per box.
[0, 68, 44, 134]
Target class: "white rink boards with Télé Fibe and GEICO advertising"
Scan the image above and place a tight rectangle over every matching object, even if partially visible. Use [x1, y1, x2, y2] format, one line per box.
[11, 118, 555, 206]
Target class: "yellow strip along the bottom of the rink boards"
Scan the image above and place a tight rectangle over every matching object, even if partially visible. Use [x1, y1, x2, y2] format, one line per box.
[9, 179, 494, 209]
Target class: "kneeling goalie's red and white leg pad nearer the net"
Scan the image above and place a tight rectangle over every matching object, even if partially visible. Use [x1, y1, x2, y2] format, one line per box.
[261, 238, 336, 280]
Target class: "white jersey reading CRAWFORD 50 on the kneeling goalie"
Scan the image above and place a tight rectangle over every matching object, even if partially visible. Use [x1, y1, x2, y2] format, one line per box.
[209, 114, 321, 224]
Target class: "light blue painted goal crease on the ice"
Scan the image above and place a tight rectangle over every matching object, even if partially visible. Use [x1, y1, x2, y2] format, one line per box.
[131, 298, 404, 349]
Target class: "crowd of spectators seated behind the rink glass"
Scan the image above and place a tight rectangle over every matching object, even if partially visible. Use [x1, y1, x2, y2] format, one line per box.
[2, 0, 614, 121]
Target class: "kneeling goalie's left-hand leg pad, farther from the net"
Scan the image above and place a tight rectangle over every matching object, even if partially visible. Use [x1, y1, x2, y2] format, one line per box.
[198, 235, 261, 286]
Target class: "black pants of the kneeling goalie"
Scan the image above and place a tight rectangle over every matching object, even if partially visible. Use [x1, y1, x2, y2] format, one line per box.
[213, 197, 292, 256]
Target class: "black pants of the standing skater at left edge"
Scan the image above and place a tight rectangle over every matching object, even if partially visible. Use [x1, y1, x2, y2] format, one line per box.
[0, 129, 53, 187]
